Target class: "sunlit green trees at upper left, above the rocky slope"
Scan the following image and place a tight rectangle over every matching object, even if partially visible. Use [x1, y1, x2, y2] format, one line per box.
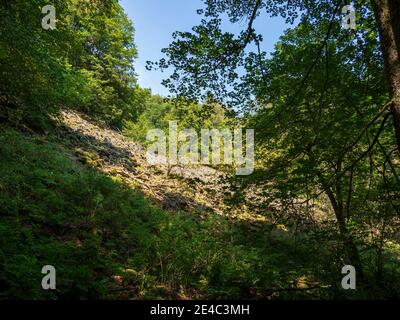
[0, 0, 143, 127]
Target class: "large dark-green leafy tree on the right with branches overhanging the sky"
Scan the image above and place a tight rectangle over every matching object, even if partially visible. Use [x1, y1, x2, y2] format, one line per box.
[155, 0, 399, 272]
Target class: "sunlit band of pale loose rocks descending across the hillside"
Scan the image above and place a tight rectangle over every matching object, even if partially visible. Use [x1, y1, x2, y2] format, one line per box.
[57, 110, 328, 230]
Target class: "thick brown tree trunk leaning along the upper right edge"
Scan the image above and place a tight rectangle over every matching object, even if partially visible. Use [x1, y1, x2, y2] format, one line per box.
[371, 0, 400, 152]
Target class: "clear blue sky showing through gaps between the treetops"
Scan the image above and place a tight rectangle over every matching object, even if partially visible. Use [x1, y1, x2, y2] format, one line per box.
[120, 0, 290, 96]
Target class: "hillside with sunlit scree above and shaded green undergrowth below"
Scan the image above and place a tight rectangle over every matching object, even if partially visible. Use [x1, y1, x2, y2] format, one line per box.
[0, 111, 324, 299]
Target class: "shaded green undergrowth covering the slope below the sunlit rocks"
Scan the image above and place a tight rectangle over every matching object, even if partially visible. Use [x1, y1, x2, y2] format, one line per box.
[0, 129, 398, 299]
